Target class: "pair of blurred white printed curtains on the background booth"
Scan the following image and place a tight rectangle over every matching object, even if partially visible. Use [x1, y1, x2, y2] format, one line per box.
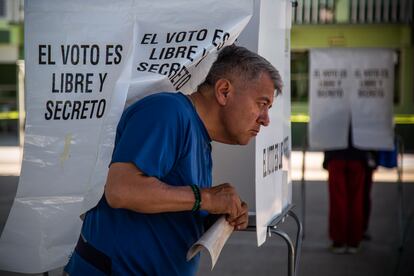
[309, 49, 395, 150]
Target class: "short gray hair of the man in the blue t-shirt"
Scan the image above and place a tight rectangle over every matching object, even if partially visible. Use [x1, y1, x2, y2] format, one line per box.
[199, 44, 282, 94]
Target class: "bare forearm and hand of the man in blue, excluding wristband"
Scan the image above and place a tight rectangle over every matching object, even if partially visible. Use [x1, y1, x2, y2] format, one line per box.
[105, 163, 247, 229]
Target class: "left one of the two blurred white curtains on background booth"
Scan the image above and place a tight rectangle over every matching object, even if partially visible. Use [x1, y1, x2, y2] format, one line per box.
[309, 49, 351, 149]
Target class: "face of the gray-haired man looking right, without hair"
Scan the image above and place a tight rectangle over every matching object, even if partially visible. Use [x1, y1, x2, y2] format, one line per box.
[222, 73, 275, 145]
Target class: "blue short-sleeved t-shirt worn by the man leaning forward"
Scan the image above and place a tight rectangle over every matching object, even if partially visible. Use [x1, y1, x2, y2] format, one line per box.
[65, 93, 212, 276]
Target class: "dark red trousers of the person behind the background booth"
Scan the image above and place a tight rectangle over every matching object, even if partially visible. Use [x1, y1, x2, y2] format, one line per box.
[328, 159, 365, 246]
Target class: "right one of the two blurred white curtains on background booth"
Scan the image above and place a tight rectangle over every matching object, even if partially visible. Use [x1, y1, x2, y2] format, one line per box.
[350, 49, 395, 150]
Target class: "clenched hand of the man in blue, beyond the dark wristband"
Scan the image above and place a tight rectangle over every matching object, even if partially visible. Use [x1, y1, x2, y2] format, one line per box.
[201, 183, 248, 230]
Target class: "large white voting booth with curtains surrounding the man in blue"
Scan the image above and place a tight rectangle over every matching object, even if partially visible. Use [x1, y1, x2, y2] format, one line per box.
[0, 0, 298, 273]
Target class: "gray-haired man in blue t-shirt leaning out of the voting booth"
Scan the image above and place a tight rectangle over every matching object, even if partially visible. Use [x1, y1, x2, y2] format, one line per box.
[65, 46, 281, 275]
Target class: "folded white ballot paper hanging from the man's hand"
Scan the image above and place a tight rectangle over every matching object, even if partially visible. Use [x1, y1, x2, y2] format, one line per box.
[187, 216, 234, 270]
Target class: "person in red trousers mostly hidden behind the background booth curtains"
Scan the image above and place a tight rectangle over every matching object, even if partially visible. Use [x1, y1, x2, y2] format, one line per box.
[323, 128, 372, 254]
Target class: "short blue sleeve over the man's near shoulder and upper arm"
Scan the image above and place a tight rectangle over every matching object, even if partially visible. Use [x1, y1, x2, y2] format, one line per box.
[112, 97, 188, 179]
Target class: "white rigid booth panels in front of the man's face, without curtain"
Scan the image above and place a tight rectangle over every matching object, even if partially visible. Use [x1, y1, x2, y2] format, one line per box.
[213, 1, 292, 245]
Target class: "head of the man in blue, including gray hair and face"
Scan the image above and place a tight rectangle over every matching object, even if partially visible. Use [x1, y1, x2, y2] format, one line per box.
[198, 45, 282, 145]
